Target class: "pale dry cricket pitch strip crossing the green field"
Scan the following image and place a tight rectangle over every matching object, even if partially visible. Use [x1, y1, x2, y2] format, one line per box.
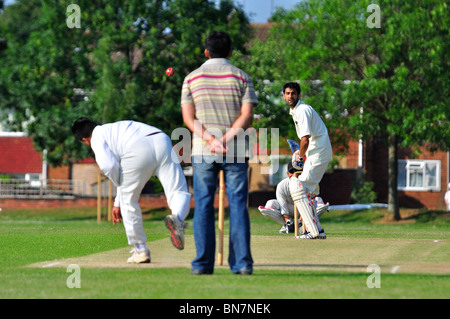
[27, 235, 450, 274]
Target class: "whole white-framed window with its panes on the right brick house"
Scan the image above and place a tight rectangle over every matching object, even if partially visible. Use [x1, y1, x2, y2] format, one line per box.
[397, 160, 441, 191]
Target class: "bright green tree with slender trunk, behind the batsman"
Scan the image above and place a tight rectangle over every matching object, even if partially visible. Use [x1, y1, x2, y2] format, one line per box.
[246, 0, 450, 219]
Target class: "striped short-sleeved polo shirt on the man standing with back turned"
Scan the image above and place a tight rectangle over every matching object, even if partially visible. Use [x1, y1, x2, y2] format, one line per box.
[181, 58, 258, 156]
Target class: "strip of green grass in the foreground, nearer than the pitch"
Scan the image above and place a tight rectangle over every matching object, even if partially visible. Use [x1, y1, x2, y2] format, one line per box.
[0, 268, 449, 299]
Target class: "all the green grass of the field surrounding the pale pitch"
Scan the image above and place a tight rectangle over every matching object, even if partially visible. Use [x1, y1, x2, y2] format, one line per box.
[0, 208, 450, 299]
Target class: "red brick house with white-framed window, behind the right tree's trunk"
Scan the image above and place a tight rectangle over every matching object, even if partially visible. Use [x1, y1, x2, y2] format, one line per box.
[321, 138, 450, 209]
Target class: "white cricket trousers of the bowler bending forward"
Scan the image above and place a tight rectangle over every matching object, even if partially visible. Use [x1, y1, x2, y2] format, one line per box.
[118, 133, 191, 245]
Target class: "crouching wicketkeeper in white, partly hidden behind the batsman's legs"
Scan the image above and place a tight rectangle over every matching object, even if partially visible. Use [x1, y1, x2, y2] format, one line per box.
[258, 162, 330, 238]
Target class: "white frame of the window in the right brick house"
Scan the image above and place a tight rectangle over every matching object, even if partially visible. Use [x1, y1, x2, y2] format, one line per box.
[397, 159, 441, 192]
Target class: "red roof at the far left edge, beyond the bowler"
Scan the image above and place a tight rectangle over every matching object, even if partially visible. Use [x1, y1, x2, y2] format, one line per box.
[0, 136, 42, 174]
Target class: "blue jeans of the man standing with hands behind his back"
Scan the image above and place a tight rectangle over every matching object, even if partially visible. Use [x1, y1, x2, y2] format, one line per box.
[192, 157, 253, 273]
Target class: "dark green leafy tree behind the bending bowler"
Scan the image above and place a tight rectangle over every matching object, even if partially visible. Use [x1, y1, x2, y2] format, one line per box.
[0, 0, 250, 165]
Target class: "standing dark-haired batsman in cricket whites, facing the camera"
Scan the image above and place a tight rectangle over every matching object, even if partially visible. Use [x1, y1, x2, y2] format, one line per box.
[283, 82, 333, 239]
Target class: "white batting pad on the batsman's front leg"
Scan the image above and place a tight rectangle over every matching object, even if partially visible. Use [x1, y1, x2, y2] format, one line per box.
[289, 177, 319, 238]
